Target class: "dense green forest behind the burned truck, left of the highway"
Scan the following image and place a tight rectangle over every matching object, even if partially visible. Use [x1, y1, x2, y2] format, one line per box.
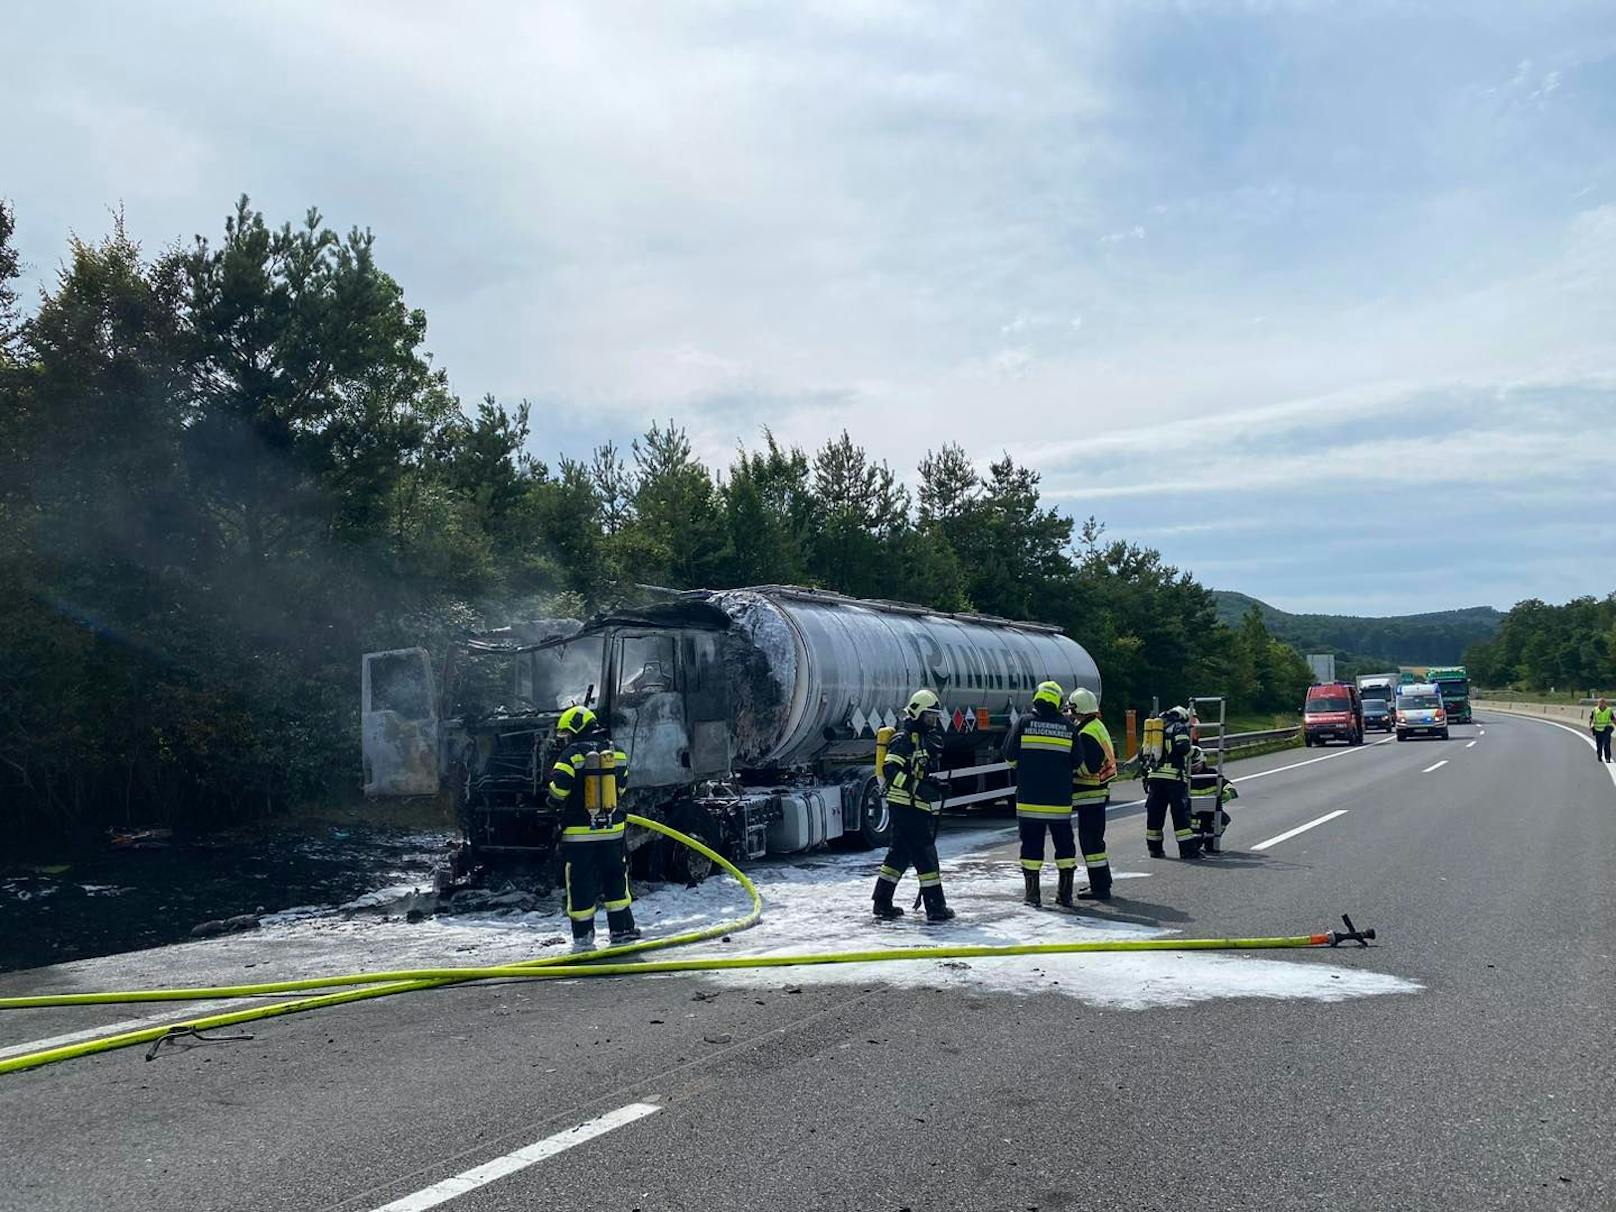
[0, 199, 1307, 840]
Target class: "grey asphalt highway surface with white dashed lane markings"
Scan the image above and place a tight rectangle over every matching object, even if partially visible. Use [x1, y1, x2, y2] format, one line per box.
[0, 714, 1616, 1212]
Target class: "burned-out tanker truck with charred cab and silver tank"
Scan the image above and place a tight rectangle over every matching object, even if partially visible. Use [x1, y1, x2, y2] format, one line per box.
[362, 585, 1100, 882]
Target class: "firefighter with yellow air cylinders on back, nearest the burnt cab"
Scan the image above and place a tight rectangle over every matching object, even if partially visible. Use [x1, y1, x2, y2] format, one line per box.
[549, 706, 640, 952]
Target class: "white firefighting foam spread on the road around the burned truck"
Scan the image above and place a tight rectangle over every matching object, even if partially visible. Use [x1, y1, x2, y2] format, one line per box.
[0, 829, 1420, 1013]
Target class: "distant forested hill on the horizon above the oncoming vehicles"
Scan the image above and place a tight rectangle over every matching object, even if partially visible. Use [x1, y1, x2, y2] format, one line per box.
[1212, 590, 1504, 666]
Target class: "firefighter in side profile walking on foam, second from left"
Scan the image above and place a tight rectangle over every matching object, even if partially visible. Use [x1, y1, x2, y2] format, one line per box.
[874, 690, 953, 921]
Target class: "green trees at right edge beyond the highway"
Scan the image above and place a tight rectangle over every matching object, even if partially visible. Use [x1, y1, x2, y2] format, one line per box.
[1464, 593, 1616, 692]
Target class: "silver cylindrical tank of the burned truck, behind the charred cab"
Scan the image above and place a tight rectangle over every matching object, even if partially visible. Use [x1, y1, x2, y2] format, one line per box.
[709, 585, 1100, 766]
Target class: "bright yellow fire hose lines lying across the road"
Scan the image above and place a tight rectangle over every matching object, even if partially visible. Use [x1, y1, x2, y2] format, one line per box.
[0, 814, 1375, 1073]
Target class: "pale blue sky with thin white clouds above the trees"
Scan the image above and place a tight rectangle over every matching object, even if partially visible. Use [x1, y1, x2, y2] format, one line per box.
[0, 0, 1616, 614]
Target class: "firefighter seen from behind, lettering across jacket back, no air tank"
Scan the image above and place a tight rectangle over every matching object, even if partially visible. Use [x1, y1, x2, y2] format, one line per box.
[1005, 682, 1078, 908]
